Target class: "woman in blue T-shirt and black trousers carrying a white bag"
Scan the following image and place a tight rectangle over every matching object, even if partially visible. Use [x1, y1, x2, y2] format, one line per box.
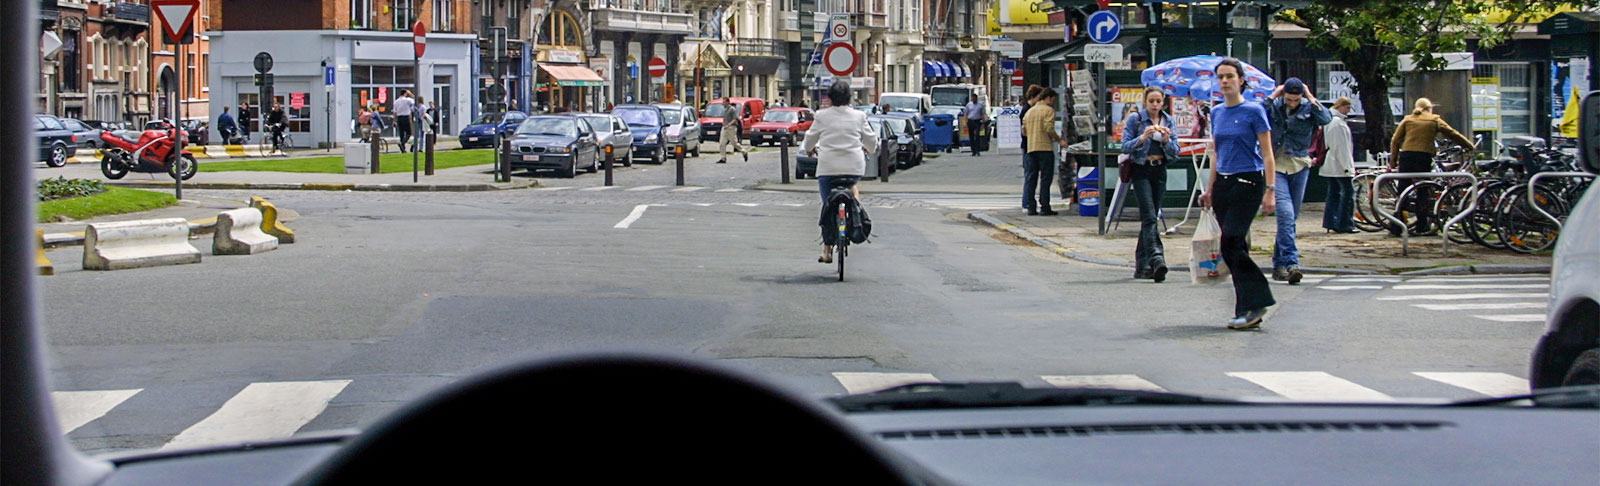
[1200, 58, 1277, 329]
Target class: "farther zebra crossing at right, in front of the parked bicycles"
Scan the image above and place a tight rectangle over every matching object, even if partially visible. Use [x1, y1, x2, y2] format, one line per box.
[1317, 275, 1550, 323]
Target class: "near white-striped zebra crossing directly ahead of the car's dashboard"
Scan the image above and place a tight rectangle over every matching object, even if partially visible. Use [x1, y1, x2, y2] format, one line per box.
[62, 371, 1528, 449]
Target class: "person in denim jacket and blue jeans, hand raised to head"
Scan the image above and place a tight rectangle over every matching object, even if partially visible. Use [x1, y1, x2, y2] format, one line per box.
[1269, 78, 1333, 285]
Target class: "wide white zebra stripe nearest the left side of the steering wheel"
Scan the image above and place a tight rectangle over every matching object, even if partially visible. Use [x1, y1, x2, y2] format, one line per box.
[162, 380, 350, 449]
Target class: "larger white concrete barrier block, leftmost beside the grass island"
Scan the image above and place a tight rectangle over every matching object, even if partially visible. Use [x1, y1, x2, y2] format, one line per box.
[83, 217, 200, 270]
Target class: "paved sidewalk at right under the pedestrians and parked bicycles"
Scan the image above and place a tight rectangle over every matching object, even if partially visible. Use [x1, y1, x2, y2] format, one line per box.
[968, 203, 1550, 275]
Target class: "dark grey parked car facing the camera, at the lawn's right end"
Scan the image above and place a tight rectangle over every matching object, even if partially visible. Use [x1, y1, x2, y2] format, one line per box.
[509, 115, 600, 177]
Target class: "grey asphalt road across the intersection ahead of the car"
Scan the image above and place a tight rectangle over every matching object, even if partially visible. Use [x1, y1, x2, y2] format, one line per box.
[31, 181, 1547, 452]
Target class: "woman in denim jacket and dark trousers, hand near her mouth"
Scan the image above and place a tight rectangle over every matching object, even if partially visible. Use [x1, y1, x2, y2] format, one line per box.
[1122, 86, 1178, 281]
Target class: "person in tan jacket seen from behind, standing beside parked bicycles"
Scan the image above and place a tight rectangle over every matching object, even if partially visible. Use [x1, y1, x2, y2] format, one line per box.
[1389, 98, 1477, 237]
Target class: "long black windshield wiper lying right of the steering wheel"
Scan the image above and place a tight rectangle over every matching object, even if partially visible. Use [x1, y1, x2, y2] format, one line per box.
[827, 382, 1243, 412]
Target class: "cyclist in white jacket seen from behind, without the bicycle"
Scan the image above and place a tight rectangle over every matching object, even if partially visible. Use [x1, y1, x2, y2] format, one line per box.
[800, 80, 878, 264]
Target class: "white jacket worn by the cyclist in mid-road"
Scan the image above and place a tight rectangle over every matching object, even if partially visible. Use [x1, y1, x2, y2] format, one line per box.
[800, 106, 878, 176]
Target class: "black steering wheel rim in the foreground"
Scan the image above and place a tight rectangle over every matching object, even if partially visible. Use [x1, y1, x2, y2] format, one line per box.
[299, 355, 933, 484]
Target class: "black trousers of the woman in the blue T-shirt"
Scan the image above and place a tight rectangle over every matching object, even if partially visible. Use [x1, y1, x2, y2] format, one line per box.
[1211, 173, 1277, 317]
